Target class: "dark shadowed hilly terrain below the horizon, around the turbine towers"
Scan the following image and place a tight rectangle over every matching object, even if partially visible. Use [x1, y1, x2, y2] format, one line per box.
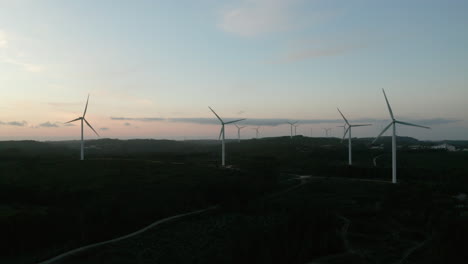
[0, 137, 468, 264]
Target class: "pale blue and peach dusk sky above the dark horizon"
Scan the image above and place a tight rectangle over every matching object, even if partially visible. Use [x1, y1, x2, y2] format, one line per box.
[0, 0, 468, 140]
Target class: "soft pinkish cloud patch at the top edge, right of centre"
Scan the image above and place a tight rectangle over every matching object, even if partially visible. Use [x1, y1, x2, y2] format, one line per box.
[218, 0, 298, 36]
